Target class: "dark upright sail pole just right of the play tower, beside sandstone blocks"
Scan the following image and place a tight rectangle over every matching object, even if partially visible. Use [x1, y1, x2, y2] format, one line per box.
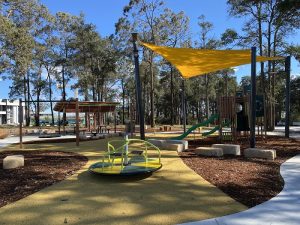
[250, 47, 256, 148]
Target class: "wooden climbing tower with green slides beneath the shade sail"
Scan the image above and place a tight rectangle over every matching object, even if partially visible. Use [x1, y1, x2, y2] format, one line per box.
[171, 92, 266, 141]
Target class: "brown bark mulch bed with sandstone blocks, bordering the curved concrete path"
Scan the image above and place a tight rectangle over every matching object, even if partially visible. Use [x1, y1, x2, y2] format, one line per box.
[180, 137, 300, 207]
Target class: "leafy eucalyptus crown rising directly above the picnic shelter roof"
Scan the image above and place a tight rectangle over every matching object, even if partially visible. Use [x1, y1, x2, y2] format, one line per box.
[74, 21, 118, 101]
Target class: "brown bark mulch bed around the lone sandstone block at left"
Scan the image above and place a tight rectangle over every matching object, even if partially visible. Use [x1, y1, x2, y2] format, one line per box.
[0, 151, 88, 207]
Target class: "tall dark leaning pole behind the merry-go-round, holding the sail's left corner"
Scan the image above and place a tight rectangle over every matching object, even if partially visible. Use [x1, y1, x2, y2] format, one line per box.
[132, 33, 145, 140]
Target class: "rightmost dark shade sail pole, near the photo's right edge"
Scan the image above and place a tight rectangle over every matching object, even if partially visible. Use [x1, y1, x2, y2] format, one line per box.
[285, 56, 291, 138]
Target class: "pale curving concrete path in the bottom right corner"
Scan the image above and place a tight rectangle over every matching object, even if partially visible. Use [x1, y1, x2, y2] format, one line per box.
[179, 155, 300, 225]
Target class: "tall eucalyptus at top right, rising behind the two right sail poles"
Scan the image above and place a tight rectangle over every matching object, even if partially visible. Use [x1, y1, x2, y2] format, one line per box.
[227, 0, 300, 129]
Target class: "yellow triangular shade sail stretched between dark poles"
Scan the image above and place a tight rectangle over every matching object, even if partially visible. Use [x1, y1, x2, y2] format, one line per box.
[140, 42, 283, 79]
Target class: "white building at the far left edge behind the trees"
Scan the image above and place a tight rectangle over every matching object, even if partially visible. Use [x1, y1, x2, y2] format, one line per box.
[0, 99, 25, 125]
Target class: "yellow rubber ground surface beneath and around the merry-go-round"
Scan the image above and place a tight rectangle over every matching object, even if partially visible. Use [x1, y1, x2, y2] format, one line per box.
[0, 139, 246, 225]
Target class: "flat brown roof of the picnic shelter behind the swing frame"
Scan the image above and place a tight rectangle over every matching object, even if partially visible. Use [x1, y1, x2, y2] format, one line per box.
[54, 101, 119, 113]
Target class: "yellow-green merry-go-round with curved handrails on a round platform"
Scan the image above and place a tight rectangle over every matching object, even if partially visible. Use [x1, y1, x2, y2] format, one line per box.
[89, 138, 162, 175]
